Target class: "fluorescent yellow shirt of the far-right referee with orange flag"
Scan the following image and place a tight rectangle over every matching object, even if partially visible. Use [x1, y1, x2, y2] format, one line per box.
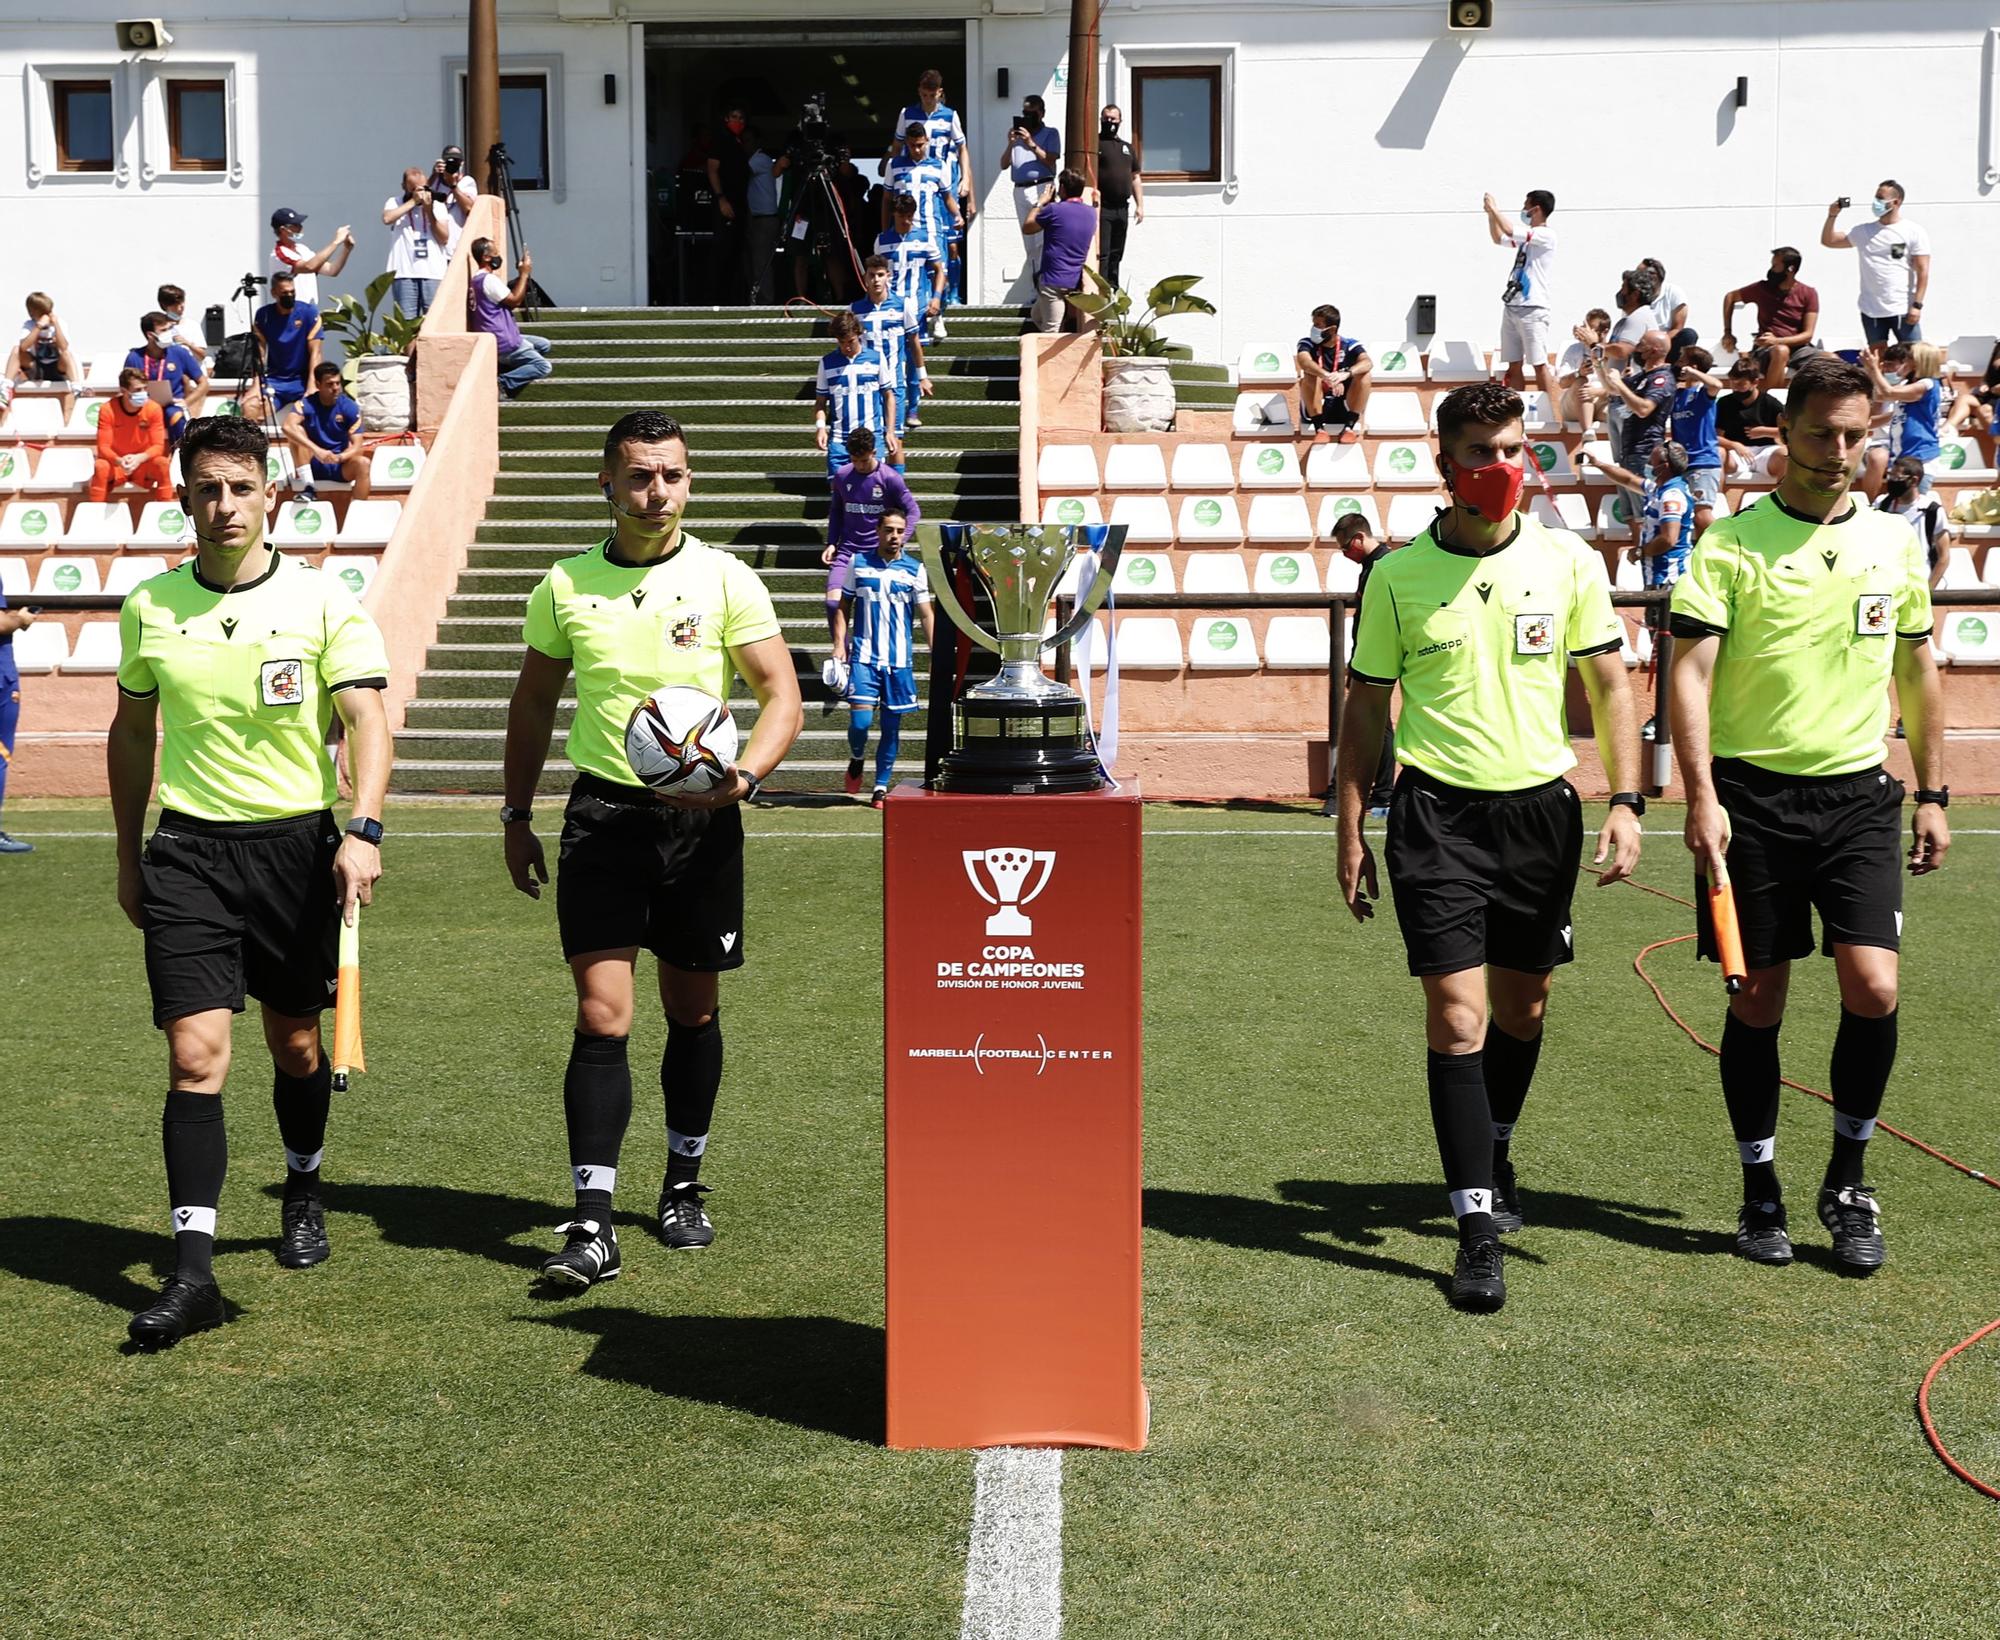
[1674, 496, 1930, 776]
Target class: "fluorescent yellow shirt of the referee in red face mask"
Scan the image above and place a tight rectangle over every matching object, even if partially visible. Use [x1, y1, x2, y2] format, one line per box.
[1350, 514, 1624, 792]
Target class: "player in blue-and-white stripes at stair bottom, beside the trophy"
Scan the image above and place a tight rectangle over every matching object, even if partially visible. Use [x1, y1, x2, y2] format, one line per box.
[834, 506, 934, 808]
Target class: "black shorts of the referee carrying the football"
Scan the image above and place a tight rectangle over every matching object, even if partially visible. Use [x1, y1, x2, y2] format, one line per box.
[556, 774, 744, 974]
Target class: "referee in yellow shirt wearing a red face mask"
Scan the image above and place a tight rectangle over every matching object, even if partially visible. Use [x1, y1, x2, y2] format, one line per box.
[1338, 382, 1646, 1310]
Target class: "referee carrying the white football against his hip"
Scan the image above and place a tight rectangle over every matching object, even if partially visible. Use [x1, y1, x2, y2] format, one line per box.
[500, 410, 800, 1290]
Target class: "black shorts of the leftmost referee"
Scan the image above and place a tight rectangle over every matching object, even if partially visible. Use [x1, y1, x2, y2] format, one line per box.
[140, 808, 340, 1026]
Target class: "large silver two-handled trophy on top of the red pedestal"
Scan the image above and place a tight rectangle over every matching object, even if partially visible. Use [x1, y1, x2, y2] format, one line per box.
[916, 524, 1126, 792]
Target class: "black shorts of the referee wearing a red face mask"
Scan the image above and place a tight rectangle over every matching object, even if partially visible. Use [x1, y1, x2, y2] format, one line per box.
[1388, 766, 1584, 974]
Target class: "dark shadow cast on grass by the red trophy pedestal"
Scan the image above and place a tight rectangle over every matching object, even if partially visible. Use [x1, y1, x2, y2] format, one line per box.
[518, 1304, 886, 1446]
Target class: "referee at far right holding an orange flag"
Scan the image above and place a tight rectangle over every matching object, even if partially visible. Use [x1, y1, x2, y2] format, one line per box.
[1672, 356, 1952, 1274]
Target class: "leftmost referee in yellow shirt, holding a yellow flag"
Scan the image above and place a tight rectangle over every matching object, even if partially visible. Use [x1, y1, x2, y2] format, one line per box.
[106, 416, 390, 1350]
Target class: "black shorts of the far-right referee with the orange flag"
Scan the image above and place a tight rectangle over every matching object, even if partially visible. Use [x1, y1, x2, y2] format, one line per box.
[1694, 758, 1902, 968]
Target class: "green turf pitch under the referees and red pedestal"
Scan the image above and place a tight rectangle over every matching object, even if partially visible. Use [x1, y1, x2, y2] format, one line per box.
[0, 802, 2000, 1640]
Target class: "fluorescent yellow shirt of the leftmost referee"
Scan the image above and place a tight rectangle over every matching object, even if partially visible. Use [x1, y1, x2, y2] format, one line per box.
[118, 552, 388, 820]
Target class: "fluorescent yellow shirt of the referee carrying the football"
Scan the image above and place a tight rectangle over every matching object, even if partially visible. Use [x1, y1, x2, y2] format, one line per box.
[522, 530, 780, 786]
